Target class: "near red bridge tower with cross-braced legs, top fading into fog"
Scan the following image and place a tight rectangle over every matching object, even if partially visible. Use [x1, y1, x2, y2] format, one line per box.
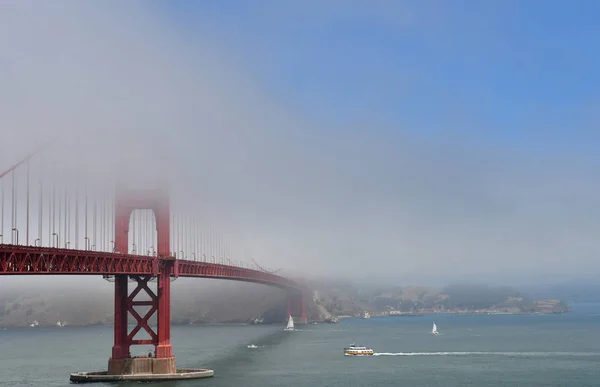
[108, 187, 176, 374]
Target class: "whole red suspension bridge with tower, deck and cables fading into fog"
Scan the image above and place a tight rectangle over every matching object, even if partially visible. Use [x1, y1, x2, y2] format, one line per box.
[0, 144, 307, 382]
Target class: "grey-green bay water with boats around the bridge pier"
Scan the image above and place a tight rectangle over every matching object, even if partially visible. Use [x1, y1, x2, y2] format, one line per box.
[0, 304, 600, 387]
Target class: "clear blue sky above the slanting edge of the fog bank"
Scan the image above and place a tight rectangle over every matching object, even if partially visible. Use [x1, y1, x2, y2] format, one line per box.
[156, 0, 600, 152]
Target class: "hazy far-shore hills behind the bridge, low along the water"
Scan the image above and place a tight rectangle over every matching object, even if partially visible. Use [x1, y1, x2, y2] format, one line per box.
[0, 278, 568, 327]
